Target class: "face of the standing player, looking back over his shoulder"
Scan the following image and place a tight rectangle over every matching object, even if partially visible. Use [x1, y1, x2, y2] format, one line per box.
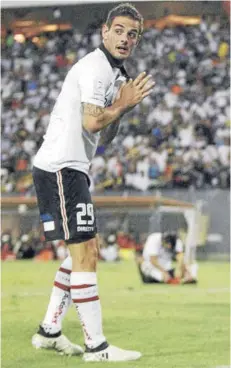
[102, 17, 140, 60]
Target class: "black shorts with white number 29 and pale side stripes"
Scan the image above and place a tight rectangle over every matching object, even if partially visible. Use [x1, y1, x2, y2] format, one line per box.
[33, 167, 97, 244]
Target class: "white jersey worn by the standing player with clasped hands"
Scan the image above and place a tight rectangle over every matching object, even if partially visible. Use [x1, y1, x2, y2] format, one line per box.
[34, 48, 125, 174]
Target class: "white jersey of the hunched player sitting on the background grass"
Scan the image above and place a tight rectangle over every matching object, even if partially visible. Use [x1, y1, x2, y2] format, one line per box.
[143, 233, 183, 270]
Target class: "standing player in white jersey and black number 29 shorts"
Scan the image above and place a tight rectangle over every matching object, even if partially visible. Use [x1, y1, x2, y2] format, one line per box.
[32, 3, 154, 361]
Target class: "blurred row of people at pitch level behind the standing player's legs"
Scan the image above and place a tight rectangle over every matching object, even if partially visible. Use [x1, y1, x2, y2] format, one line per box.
[1, 228, 142, 262]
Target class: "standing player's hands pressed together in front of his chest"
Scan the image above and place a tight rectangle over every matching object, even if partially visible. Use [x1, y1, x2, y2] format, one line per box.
[119, 72, 155, 109]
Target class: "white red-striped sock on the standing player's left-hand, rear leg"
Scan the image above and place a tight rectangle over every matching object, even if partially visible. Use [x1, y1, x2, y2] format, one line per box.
[41, 256, 72, 334]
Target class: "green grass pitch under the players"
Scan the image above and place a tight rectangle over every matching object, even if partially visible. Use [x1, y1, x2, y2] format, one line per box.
[2, 261, 229, 368]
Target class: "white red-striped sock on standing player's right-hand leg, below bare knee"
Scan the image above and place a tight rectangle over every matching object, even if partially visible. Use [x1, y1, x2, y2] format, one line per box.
[71, 272, 106, 349]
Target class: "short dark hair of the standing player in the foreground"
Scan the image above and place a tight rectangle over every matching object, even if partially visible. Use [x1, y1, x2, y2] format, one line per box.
[106, 3, 144, 35]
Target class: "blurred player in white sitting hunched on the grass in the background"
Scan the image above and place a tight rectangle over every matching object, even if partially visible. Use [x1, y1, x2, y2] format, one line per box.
[136, 233, 198, 284]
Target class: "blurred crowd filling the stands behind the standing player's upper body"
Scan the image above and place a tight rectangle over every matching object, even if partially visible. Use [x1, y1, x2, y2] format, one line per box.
[1, 17, 230, 195]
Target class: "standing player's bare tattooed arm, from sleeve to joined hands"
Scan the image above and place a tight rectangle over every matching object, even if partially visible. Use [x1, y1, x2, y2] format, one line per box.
[83, 73, 155, 133]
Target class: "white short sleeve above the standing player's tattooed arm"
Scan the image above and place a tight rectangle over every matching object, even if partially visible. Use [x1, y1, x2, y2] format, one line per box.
[78, 67, 108, 107]
